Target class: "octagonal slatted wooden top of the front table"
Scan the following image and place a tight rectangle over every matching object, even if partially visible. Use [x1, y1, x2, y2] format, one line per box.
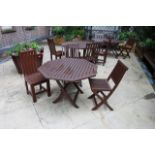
[38, 58, 97, 82]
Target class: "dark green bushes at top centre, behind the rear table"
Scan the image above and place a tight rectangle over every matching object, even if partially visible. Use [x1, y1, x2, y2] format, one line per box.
[52, 26, 85, 41]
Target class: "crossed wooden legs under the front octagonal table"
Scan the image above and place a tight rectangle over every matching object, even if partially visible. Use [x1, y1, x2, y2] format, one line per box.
[53, 80, 83, 108]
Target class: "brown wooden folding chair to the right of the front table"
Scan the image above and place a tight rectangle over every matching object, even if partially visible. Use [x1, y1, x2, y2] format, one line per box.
[88, 60, 128, 110]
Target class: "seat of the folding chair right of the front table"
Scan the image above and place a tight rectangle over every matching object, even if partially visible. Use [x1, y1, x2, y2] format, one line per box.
[89, 79, 112, 92]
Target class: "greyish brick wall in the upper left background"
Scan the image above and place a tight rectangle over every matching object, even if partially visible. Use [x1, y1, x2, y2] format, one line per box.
[0, 26, 50, 49]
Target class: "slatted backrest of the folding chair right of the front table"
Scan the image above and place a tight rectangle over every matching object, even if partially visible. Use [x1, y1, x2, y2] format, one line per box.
[108, 60, 128, 90]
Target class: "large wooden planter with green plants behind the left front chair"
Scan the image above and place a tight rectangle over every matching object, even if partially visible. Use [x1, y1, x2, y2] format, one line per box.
[8, 42, 44, 74]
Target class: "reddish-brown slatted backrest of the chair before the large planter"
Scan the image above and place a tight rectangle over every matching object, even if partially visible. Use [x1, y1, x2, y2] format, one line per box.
[19, 50, 40, 76]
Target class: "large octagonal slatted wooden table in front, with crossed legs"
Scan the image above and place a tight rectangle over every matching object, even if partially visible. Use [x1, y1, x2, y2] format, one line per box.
[38, 58, 97, 108]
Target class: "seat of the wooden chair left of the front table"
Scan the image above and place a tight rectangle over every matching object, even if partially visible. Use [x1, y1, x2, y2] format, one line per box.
[25, 72, 47, 85]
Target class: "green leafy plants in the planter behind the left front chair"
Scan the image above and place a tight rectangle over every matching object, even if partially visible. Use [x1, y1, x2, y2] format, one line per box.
[8, 42, 41, 55]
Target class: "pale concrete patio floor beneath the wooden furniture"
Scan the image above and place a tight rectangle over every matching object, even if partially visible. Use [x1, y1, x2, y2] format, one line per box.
[0, 44, 155, 129]
